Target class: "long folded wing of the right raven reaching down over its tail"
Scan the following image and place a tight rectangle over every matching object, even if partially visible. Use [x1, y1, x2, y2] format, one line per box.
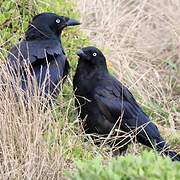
[94, 77, 164, 147]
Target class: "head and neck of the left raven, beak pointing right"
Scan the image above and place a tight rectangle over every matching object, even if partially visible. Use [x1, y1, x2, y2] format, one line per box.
[25, 13, 80, 40]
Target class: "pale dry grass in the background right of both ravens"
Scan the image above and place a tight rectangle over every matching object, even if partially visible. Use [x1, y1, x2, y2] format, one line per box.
[76, 0, 180, 136]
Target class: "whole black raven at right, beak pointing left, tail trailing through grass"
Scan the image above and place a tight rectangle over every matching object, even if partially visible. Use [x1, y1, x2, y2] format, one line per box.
[73, 47, 180, 161]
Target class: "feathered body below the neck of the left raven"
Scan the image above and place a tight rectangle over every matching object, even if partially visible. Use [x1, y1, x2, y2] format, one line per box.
[8, 40, 69, 100]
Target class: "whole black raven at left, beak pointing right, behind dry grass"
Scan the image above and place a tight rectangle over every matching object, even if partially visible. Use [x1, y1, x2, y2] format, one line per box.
[8, 13, 80, 99]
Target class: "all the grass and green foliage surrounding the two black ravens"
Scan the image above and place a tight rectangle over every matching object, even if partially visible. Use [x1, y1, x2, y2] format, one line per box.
[0, 0, 180, 179]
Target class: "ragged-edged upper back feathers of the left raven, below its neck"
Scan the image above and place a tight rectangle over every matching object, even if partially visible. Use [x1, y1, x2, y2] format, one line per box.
[8, 40, 66, 69]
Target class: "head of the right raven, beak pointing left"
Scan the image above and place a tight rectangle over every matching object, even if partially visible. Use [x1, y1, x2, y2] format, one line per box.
[76, 46, 107, 68]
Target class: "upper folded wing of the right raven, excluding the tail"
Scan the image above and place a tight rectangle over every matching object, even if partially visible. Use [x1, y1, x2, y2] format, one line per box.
[94, 76, 141, 121]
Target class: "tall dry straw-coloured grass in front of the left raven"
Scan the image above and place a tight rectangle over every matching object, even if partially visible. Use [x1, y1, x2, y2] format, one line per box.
[0, 58, 61, 179]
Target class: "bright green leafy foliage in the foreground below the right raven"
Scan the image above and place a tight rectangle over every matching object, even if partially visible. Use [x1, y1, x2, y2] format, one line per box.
[66, 151, 180, 180]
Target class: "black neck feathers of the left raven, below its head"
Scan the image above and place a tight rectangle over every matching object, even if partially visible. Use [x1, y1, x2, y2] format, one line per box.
[25, 24, 60, 41]
